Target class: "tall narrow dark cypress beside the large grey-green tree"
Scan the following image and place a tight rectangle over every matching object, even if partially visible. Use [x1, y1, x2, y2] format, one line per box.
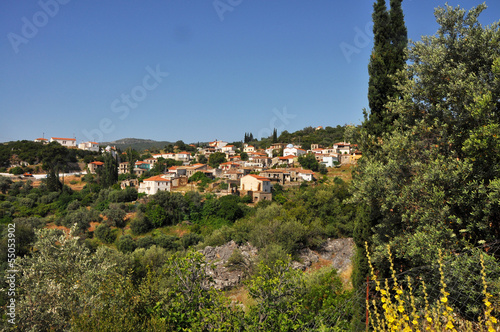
[352, 0, 408, 330]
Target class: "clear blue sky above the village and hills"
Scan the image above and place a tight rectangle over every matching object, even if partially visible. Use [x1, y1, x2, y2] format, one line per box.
[0, 0, 500, 142]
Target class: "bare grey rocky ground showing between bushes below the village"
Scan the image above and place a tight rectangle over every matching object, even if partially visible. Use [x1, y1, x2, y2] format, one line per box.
[201, 238, 355, 289]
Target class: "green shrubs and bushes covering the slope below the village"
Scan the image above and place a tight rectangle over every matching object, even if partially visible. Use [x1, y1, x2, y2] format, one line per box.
[0, 165, 354, 330]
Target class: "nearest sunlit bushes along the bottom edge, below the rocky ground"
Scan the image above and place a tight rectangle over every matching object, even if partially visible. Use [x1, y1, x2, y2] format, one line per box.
[2, 228, 349, 331]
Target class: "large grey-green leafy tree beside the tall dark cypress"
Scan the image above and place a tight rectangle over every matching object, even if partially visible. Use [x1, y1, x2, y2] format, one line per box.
[351, 5, 500, 330]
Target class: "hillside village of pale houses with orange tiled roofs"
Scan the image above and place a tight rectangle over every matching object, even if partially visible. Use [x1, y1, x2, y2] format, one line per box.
[30, 137, 361, 202]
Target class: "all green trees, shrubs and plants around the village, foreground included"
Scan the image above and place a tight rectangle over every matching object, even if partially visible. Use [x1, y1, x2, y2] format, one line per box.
[0, 0, 500, 331]
